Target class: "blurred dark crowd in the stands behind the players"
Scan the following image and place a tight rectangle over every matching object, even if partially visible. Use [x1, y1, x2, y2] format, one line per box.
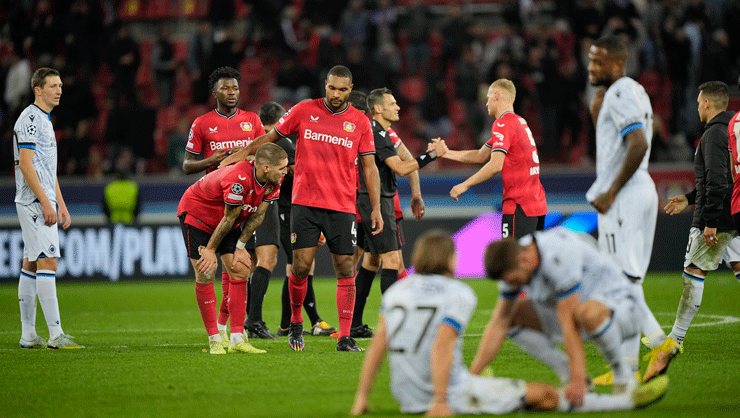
[0, 0, 740, 177]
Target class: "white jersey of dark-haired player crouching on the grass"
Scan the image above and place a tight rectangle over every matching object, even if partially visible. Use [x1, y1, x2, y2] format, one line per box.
[499, 228, 631, 306]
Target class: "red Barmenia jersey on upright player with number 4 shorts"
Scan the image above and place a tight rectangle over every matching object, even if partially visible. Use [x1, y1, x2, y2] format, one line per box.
[275, 99, 375, 213]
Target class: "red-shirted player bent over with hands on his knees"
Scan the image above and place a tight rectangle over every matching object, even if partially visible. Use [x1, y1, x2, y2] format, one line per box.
[177, 144, 288, 354]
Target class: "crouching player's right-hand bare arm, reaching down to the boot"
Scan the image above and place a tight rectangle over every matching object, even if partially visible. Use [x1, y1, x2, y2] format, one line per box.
[557, 292, 587, 406]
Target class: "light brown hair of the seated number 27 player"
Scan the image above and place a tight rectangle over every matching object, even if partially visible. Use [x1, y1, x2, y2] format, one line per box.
[411, 229, 455, 275]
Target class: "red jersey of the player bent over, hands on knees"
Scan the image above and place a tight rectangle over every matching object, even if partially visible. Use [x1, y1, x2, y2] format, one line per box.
[177, 161, 280, 233]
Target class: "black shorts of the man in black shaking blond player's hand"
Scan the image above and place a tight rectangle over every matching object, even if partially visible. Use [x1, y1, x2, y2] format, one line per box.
[357, 193, 401, 254]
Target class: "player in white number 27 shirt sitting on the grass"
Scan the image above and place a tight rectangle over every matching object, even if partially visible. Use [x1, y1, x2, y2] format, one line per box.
[352, 231, 668, 416]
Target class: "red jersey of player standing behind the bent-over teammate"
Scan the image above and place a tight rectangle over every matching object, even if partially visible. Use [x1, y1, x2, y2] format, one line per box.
[185, 109, 265, 173]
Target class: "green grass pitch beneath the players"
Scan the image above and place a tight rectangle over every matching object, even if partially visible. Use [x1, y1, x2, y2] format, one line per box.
[0, 271, 740, 418]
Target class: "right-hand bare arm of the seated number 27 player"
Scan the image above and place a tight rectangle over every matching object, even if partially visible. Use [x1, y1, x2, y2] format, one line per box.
[426, 324, 457, 417]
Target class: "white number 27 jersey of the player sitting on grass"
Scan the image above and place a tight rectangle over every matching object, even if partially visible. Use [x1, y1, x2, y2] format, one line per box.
[381, 274, 477, 413]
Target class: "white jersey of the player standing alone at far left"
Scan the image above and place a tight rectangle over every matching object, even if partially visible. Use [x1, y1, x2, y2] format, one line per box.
[13, 104, 57, 206]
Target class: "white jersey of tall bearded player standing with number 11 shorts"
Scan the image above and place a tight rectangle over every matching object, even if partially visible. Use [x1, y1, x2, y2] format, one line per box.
[586, 77, 653, 202]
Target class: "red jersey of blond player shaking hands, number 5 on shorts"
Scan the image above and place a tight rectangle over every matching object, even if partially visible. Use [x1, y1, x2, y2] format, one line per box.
[486, 112, 547, 216]
